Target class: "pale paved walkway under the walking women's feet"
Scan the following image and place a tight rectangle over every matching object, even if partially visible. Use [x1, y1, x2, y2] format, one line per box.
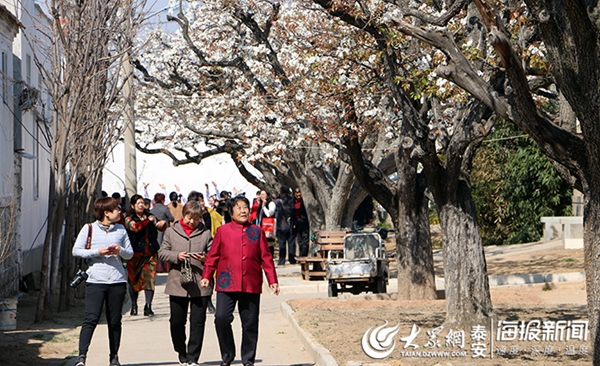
[75, 266, 327, 366]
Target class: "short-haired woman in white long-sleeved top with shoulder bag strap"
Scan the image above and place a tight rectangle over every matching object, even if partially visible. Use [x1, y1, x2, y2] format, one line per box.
[73, 197, 133, 366]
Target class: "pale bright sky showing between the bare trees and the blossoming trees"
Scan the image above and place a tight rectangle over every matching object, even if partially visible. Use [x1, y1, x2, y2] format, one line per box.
[102, 0, 258, 197]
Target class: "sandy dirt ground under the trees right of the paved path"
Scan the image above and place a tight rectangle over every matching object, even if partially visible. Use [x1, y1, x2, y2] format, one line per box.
[290, 244, 591, 366]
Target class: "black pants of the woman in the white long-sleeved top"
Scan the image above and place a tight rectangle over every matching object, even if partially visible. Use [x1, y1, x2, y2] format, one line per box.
[79, 283, 127, 360]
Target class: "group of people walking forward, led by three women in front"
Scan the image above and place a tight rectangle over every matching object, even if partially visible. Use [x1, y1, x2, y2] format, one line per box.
[73, 191, 279, 366]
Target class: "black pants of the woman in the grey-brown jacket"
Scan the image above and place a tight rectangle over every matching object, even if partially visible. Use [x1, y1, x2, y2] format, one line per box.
[169, 296, 210, 363]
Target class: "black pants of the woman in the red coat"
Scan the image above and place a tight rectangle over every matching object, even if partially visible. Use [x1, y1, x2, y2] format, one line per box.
[215, 292, 260, 365]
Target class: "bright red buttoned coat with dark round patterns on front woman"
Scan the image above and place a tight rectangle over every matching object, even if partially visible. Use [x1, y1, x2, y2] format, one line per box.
[202, 221, 277, 294]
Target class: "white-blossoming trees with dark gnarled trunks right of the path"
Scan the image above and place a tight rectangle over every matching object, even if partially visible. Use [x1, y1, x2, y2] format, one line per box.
[131, 0, 600, 363]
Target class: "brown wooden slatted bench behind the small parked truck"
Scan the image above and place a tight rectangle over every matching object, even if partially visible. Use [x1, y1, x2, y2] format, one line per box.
[296, 230, 346, 280]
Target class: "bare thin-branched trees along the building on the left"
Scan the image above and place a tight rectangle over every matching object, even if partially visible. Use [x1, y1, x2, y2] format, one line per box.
[26, 0, 149, 321]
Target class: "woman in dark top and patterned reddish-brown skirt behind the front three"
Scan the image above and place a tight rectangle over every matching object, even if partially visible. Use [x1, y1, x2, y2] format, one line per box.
[125, 194, 167, 316]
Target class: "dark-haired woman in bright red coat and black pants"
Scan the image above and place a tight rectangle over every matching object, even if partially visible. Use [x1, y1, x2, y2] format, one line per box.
[200, 196, 279, 366]
